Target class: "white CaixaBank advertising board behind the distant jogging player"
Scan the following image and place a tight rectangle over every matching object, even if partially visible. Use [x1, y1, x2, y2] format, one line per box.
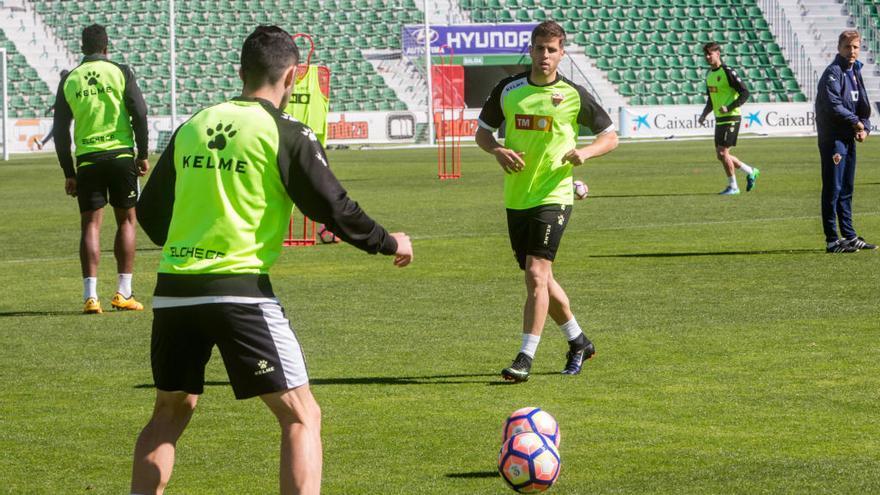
[620, 103, 816, 138]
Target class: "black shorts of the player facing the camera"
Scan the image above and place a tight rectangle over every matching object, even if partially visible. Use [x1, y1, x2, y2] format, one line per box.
[507, 205, 571, 270]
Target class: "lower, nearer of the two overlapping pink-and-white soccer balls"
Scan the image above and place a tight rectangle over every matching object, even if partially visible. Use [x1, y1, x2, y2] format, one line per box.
[498, 431, 562, 493]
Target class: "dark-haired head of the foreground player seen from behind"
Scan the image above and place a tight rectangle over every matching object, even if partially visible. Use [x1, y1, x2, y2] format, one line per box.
[241, 26, 299, 88]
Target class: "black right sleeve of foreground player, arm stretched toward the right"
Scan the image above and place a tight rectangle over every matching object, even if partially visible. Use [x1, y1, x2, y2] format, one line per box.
[278, 117, 397, 255]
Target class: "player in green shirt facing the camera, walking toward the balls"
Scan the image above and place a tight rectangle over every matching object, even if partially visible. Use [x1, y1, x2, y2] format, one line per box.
[476, 21, 617, 382]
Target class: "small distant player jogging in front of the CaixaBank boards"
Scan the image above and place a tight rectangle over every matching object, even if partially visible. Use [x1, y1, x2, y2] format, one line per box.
[700, 41, 761, 196]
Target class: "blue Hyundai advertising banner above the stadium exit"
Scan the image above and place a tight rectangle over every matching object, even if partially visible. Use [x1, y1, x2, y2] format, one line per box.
[403, 24, 537, 57]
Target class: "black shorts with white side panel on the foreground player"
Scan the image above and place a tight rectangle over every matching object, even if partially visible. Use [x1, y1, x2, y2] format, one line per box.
[151, 297, 309, 399]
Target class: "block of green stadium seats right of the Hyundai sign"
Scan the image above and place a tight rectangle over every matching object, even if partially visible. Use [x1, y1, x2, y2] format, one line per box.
[460, 0, 807, 105]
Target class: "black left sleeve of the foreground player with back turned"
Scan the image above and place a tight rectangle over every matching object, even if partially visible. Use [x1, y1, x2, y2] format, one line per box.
[136, 132, 177, 246]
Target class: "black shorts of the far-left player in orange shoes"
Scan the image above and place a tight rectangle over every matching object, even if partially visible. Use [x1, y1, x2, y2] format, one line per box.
[76, 156, 141, 213]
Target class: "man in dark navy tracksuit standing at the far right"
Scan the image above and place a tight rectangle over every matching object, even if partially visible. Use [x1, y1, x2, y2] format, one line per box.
[816, 31, 877, 253]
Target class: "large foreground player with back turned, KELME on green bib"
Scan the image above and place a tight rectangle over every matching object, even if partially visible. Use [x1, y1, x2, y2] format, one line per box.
[129, 26, 412, 495]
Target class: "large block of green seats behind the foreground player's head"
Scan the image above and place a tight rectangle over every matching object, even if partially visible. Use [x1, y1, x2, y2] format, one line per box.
[33, 0, 410, 115]
